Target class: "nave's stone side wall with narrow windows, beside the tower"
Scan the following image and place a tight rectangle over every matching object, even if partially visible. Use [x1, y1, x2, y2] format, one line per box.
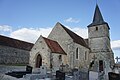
[74, 43, 90, 69]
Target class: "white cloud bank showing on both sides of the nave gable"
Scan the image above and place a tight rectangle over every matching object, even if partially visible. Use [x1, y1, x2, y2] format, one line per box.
[10, 27, 87, 43]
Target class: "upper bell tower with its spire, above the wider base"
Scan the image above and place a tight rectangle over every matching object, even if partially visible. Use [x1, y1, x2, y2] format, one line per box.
[88, 5, 110, 52]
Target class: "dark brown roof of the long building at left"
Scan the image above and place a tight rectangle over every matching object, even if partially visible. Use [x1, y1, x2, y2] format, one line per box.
[0, 35, 34, 51]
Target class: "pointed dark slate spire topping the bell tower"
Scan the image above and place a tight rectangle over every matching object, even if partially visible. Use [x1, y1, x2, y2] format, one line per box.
[89, 4, 106, 26]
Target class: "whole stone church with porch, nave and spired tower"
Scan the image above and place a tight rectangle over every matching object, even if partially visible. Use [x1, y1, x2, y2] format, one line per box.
[29, 5, 114, 78]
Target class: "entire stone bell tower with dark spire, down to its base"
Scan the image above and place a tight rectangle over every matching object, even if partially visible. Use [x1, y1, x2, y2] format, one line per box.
[88, 5, 114, 78]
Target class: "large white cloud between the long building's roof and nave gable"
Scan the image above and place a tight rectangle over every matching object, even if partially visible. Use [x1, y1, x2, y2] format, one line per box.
[10, 28, 52, 43]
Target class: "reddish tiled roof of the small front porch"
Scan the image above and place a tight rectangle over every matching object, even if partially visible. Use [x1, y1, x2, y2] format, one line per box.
[43, 37, 66, 55]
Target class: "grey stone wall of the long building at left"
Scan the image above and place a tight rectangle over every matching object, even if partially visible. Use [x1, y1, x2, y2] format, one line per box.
[0, 46, 29, 64]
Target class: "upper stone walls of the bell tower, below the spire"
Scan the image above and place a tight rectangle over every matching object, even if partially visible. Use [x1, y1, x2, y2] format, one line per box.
[88, 24, 111, 52]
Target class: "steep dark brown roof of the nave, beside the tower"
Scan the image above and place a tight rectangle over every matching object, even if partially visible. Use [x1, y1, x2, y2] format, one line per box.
[58, 22, 89, 48]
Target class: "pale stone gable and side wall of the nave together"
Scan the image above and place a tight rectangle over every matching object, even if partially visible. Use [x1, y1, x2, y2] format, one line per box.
[48, 23, 89, 68]
